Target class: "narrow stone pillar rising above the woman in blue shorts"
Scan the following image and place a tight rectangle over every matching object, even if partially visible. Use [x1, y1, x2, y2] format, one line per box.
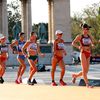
[21, 0, 32, 39]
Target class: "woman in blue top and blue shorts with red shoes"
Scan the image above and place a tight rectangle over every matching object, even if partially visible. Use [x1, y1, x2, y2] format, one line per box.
[10, 32, 26, 84]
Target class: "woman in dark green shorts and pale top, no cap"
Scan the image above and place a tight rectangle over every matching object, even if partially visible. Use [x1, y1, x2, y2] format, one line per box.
[22, 32, 44, 85]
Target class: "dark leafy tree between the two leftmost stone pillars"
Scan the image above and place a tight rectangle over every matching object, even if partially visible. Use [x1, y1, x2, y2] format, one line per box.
[7, 0, 21, 42]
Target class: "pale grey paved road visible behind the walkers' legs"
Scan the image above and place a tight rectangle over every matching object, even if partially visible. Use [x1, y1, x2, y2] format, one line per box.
[4, 64, 100, 85]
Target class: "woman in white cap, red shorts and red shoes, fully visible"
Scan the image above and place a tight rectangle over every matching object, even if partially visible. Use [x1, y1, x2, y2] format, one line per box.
[51, 30, 67, 86]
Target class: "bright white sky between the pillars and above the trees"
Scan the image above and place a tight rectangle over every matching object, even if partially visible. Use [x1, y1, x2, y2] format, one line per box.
[7, 0, 100, 23]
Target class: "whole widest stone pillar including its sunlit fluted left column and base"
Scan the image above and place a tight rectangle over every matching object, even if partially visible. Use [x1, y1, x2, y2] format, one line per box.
[48, 0, 72, 63]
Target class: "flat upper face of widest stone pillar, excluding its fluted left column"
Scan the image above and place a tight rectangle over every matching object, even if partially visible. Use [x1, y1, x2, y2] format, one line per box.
[53, 0, 72, 42]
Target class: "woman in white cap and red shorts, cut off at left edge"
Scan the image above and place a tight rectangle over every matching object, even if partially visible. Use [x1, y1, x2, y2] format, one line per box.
[0, 34, 8, 84]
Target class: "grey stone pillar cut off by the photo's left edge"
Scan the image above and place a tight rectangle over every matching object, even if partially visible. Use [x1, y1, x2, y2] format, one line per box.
[0, 0, 8, 38]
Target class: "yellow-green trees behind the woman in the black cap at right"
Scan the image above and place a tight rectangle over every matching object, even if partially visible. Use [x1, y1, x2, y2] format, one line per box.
[71, 3, 100, 54]
